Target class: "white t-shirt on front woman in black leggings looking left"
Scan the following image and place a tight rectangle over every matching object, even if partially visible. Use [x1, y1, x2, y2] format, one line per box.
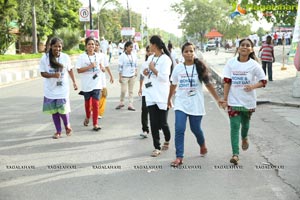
[144, 54, 172, 110]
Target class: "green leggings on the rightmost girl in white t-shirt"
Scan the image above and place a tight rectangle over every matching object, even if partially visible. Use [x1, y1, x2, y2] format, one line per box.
[230, 111, 251, 155]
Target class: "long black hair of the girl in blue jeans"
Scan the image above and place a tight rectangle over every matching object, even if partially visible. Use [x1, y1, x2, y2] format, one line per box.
[181, 42, 209, 83]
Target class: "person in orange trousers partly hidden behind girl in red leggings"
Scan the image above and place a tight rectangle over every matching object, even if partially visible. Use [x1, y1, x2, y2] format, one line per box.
[95, 40, 114, 119]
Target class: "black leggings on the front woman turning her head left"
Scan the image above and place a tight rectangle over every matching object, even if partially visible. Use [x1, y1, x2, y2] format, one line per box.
[148, 104, 171, 150]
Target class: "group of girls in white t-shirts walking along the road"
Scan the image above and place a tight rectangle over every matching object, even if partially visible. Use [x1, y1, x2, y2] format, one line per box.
[40, 35, 270, 167]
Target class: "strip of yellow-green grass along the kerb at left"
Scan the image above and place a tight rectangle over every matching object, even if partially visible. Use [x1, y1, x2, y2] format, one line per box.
[0, 50, 83, 62]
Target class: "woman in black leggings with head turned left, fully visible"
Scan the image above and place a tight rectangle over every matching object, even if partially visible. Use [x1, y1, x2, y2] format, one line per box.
[143, 35, 173, 157]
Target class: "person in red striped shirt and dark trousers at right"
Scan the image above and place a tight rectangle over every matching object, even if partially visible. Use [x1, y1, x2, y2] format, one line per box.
[259, 35, 275, 81]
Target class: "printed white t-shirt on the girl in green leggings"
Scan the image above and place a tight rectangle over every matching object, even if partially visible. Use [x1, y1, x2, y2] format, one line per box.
[223, 57, 266, 109]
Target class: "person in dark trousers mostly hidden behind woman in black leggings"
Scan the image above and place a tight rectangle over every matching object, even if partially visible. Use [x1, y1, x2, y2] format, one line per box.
[138, 45, 152, 138]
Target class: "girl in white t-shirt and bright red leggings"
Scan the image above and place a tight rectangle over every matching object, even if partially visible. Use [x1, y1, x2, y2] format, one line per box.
[76, 37, 105, 131]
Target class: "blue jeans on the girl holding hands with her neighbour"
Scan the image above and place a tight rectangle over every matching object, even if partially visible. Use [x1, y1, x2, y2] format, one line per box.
[175, 110, 205, 158]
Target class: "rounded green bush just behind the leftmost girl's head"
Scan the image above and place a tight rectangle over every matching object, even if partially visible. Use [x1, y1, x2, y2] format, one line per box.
[57, 28, 80, 51]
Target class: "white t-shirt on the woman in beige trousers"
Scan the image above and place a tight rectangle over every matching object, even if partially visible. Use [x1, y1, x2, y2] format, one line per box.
[119, 52, 137, 77]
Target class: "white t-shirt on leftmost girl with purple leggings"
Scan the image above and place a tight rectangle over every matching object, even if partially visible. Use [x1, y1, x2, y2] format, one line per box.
[39, 53, 73, 99]
